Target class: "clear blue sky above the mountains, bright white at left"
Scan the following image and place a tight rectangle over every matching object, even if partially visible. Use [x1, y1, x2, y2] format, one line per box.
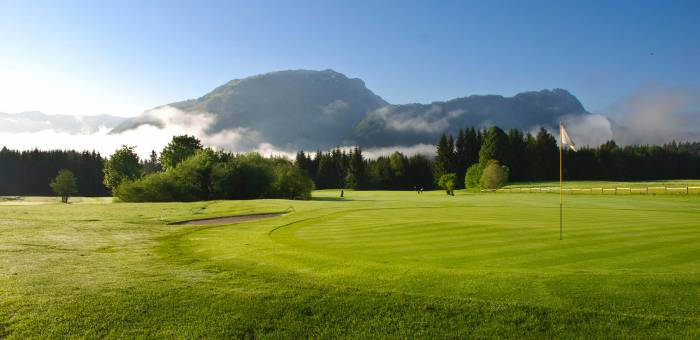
[0, 0, 700, 116]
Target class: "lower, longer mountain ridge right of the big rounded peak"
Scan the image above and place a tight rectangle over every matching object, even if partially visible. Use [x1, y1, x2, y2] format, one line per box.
[353, 89, 587, 146]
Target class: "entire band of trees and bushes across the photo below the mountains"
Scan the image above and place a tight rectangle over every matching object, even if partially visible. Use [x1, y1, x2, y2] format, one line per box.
[0, 126, 700, 200]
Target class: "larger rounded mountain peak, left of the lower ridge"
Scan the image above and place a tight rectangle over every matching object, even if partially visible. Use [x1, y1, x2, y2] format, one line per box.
[113, 70, 388, 149]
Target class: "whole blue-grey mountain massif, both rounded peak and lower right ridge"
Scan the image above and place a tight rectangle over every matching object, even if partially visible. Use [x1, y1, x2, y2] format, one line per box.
[112, 70, 587, 150]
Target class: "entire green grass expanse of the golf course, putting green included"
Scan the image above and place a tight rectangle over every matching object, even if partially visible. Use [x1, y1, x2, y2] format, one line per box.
[0, 191, 700, 338]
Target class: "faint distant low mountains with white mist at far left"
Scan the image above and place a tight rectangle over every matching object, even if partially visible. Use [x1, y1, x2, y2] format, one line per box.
[0, 111, 126, 134]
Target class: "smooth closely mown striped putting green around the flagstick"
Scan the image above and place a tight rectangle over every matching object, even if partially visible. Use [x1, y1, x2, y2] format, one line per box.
[180, 193, 700, 334]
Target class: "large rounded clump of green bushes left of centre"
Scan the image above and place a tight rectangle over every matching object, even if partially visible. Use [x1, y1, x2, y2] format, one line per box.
[114, 149, 314, 202]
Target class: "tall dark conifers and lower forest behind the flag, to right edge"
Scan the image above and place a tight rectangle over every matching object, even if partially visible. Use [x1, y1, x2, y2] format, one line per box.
[433, 126, 700, 187]
